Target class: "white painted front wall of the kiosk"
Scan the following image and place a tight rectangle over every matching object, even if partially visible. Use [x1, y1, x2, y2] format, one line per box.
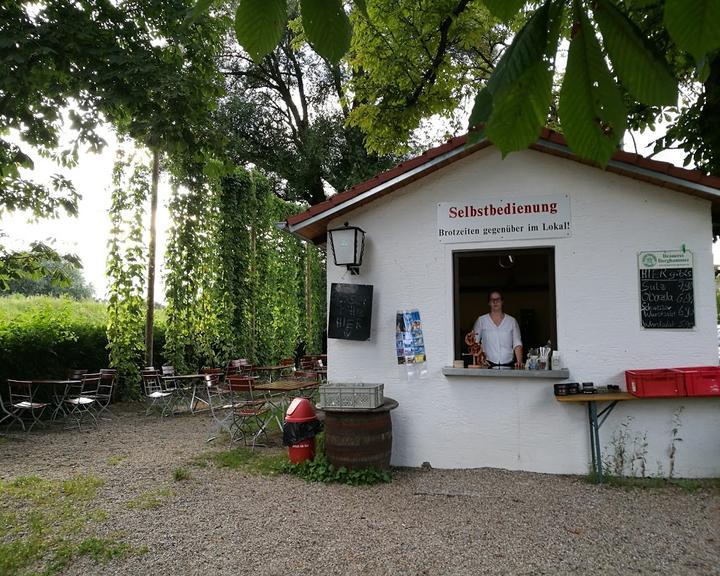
[328, 148, 720, 477]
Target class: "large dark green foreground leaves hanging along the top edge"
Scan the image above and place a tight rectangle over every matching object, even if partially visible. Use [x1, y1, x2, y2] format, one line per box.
[229, 0, 720, 172]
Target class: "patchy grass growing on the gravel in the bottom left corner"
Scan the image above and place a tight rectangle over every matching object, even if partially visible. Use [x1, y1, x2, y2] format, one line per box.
[0, 476, 131, 576]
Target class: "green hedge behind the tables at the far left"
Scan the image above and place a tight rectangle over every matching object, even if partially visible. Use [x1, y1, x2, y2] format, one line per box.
[0, 295, 165, 396]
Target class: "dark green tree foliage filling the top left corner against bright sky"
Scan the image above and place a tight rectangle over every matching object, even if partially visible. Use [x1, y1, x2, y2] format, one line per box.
[0, 0, 224, 215]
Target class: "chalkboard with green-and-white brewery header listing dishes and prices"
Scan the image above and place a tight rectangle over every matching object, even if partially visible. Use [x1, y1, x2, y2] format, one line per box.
[638, 250, 695, 328]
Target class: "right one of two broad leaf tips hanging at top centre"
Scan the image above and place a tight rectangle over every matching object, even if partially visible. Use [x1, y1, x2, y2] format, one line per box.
[300, 0, 352, 62]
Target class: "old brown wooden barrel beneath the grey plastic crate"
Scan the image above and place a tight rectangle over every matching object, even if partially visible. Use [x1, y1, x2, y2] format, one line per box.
[325, 399, 397, 470]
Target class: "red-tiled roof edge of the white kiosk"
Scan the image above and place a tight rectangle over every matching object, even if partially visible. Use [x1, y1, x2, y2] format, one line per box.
[286, 128, 720, 243]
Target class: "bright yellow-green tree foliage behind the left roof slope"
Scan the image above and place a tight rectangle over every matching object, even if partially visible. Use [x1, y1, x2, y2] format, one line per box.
[347, 0, 504, 153]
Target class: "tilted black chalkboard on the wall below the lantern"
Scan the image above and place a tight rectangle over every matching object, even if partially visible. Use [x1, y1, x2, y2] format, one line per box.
[328, 284, 373, 340]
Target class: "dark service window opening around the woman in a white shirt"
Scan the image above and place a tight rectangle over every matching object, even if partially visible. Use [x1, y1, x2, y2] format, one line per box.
[453, 247, 558, 360]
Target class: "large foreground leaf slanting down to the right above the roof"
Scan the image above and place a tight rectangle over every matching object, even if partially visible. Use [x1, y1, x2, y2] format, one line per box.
[594, 0, 677, 106]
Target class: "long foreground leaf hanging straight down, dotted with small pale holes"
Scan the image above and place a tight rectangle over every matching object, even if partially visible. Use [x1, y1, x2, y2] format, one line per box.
[558, 0, 626, 167]
